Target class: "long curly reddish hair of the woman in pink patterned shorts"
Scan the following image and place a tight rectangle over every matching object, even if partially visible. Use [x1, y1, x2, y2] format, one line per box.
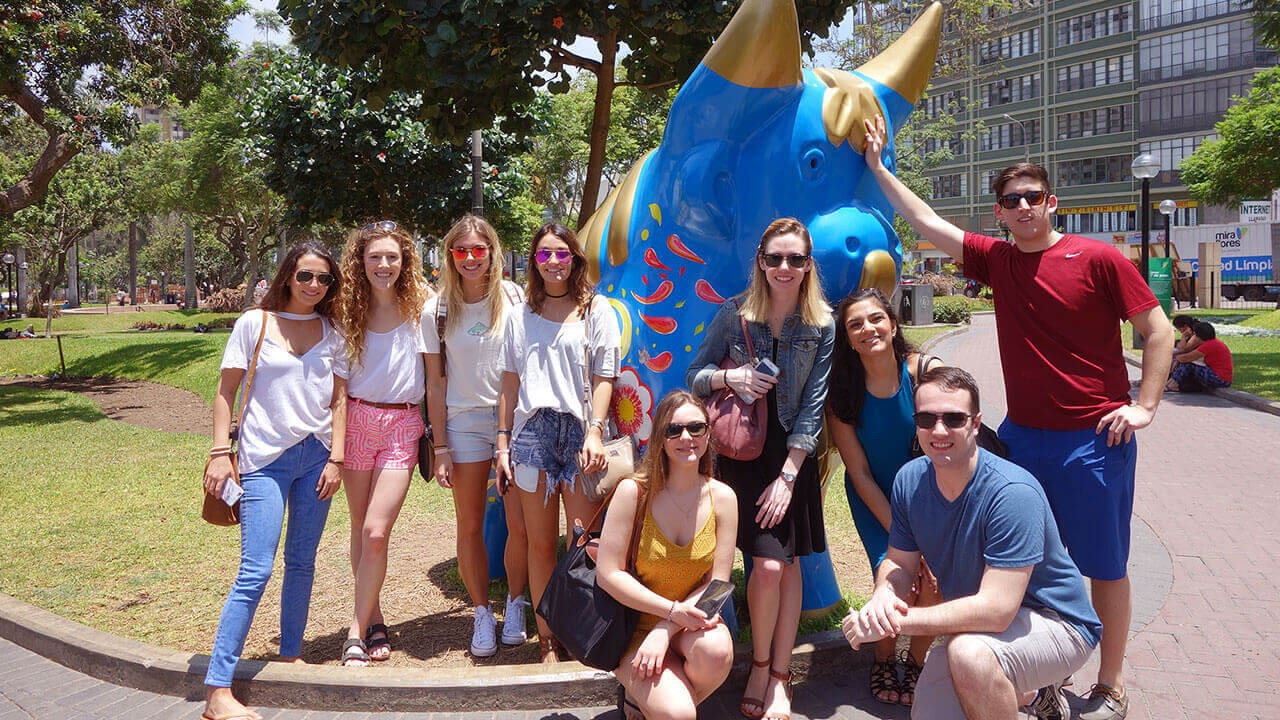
[338, 225, 429, 364]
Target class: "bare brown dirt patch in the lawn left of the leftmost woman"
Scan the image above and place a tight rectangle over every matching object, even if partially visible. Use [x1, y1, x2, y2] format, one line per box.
[0, 378, 214, 437]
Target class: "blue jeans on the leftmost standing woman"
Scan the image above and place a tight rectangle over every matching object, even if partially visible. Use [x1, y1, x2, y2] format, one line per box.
[205, 436, 329, 688]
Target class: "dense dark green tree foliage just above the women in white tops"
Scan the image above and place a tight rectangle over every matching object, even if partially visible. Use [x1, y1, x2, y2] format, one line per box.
[239, 50, 545, 245]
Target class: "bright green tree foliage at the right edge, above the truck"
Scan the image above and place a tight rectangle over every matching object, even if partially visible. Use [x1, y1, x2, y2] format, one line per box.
[1180, 68, 1280, 205]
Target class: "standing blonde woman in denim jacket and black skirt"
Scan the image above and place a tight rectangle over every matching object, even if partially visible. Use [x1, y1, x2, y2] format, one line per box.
[686, 218, 835, 719]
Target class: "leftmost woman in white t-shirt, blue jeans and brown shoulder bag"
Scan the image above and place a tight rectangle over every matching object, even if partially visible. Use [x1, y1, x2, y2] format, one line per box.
[205, 243, 346, 717]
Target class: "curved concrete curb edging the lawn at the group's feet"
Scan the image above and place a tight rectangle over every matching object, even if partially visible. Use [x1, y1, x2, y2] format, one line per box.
[0, 593, 872, 712]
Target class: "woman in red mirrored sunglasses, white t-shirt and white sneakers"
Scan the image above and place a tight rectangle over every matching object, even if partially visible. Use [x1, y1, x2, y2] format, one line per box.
[422, 214, 529, 657]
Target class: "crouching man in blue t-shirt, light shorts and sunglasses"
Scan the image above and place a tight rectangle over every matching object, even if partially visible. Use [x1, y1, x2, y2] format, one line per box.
[844, 368, 1102, 720]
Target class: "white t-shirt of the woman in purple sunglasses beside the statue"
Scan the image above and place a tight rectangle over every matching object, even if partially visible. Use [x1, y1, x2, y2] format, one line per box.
[502, 296, 622, 438]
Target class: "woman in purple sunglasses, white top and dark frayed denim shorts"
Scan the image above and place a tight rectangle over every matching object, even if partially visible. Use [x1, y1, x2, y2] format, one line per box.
[497, 223, 622, 662]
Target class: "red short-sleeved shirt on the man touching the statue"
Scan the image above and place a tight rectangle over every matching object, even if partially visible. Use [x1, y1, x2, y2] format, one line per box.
[964, 233, 1158, 430]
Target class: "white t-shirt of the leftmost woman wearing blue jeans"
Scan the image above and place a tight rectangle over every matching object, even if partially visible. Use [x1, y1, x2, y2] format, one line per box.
[221, 310, 347, 473]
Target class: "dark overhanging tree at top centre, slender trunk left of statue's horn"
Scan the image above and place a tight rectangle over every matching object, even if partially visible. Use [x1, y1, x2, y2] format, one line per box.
[278, 0, 846, 223]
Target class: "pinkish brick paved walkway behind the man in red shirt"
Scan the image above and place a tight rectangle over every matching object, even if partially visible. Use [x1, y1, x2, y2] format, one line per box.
[934, 315, 1280, 720]
